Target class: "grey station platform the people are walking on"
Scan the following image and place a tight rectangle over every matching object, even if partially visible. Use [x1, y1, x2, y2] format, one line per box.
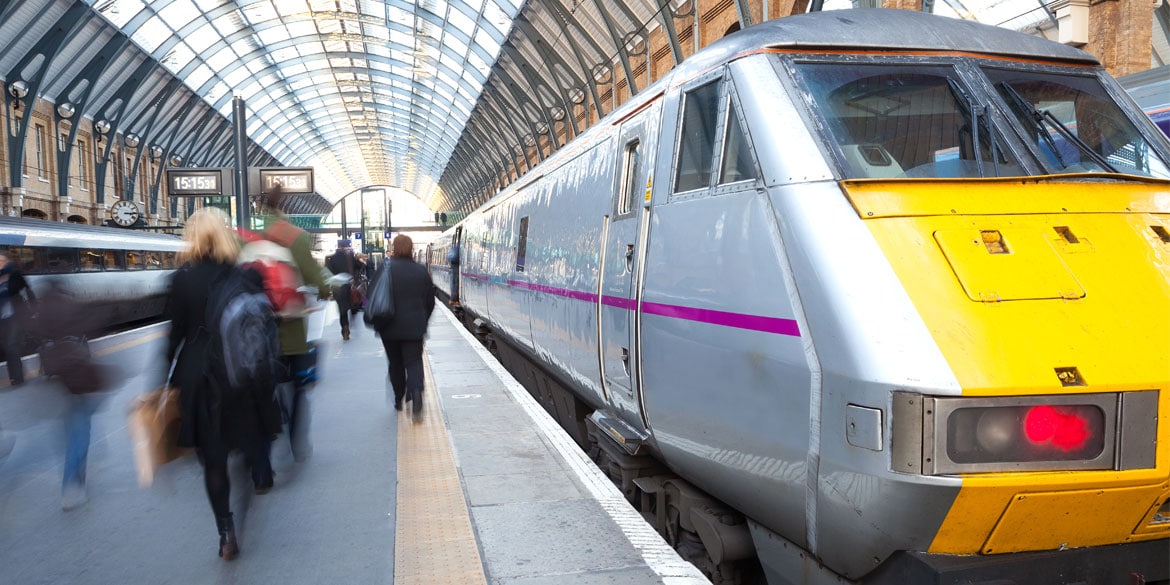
[0, 309, 708, 585]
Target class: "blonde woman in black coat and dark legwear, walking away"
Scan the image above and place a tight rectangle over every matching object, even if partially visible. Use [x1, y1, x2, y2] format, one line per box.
[166, 207, 281, 560]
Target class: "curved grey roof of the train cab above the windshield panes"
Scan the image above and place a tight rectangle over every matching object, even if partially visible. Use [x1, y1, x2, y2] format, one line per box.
[680, 8, 1097, 78]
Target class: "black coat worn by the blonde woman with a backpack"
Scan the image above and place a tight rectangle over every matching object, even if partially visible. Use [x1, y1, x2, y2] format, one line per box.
[166, 261, 281, 449]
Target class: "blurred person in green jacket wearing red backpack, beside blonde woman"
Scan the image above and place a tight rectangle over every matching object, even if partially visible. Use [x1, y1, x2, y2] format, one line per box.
[257, 186, 329, 461]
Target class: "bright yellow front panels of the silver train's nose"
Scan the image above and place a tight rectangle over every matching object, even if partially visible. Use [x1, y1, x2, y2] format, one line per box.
[844, 180, 1170, 553]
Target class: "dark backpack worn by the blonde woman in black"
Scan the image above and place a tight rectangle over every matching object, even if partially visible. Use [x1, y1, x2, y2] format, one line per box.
[206, 268, 280, 394]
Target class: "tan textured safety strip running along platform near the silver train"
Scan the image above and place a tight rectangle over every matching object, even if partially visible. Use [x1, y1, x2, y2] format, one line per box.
[394, 358, 487, 585]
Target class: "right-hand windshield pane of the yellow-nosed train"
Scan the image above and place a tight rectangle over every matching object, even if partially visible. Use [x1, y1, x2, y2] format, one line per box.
[984, 68, 1170, 178]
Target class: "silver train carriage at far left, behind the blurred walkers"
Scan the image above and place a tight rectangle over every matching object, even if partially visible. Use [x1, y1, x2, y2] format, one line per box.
[0, 218, 184, 328]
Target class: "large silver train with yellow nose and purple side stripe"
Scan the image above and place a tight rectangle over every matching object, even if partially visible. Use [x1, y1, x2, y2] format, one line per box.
[426, 9, 1170, 585]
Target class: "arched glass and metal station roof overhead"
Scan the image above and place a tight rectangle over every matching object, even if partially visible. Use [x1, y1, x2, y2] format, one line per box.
[0, 0, 1160, 212]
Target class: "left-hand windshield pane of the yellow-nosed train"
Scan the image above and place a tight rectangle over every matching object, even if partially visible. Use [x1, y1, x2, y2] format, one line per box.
[797, 63, 1026, 179]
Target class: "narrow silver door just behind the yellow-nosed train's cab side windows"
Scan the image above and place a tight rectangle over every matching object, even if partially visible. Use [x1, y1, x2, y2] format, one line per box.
[598, 109, 656, 431]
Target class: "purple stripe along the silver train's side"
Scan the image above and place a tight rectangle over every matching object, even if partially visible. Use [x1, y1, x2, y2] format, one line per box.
[460, 273, 800, 337]
